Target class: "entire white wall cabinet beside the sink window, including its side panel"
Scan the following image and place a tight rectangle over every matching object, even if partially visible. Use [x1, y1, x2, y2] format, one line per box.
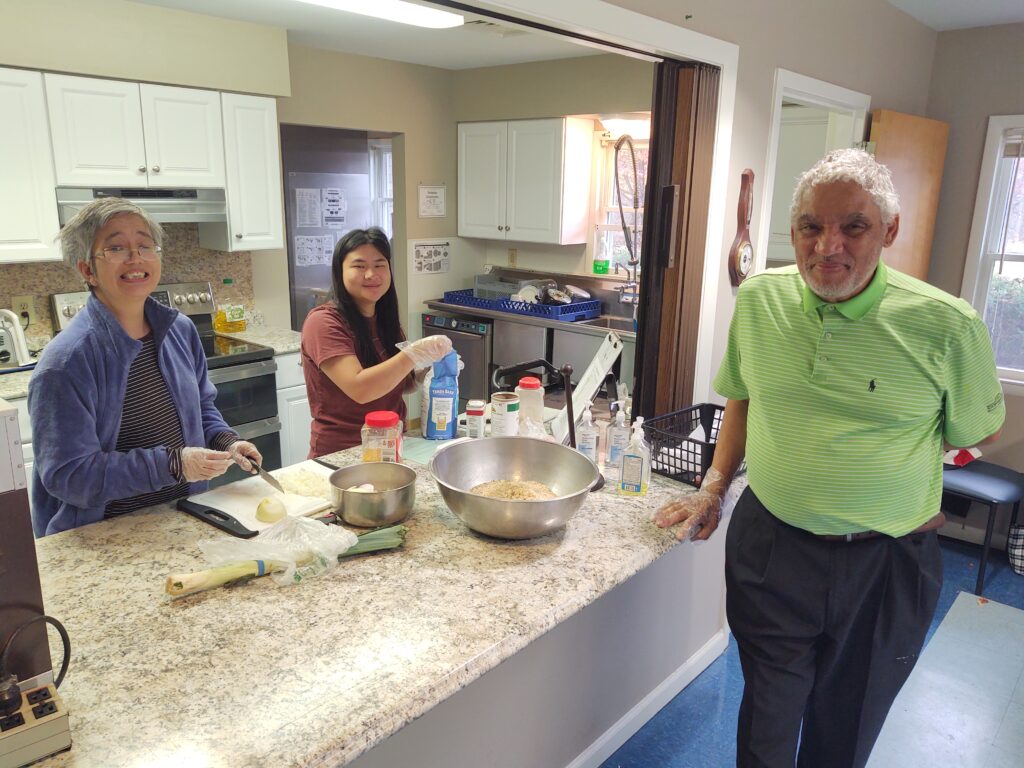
[459, 118, 594, 245]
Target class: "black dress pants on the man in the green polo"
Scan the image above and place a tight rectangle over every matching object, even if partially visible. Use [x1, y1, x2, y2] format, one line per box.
[725, 488, 942, 768]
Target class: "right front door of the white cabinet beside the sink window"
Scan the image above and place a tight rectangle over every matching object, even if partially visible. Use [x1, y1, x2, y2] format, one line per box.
[505, 120, 565, 243]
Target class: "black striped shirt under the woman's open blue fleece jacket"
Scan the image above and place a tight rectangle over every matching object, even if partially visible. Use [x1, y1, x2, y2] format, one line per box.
[103, 334, 188, 517]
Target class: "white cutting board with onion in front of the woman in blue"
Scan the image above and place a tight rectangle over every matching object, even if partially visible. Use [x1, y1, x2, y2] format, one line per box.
[177, 459, 334, 538]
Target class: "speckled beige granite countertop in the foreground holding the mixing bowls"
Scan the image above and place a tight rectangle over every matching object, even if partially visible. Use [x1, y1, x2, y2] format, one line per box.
[37, 450, 693, 768]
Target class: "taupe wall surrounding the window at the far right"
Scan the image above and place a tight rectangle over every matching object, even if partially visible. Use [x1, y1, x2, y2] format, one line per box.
[928, 24, 1024, 472]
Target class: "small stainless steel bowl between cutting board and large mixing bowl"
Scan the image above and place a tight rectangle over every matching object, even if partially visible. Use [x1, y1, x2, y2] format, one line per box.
[329, 462, 416, 528]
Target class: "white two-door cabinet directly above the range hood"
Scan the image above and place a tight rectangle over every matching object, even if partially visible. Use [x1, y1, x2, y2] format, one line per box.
[45, 74, 224, 187]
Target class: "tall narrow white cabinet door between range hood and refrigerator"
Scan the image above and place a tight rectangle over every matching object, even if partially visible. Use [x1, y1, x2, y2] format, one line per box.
[215, 93, 285, 251]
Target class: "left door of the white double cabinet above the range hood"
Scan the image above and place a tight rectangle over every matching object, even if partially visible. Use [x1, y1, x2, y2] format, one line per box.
[44, 74, 148, 186]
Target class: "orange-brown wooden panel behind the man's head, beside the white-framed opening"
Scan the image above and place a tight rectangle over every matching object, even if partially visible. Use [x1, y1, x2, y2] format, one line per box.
[870, 110, 949, 280]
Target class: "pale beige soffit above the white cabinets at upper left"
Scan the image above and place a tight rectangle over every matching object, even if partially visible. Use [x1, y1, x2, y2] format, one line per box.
[0, 0, 289, 96]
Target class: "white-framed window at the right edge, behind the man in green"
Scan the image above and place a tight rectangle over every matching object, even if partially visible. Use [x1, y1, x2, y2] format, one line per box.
[963, 115, 1024, 384]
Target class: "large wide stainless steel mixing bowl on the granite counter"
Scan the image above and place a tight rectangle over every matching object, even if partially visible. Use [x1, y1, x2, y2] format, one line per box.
[430, 437, 600, 539]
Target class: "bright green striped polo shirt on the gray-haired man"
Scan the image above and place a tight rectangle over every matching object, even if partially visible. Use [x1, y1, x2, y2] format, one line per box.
[715, 262, 1005, 537]
